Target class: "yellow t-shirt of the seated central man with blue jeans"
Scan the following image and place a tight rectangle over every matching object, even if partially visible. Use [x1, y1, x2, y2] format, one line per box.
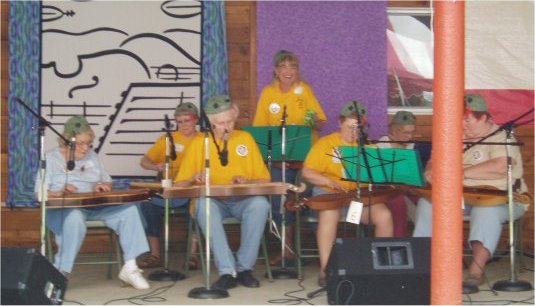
[175, 130, 271, 185]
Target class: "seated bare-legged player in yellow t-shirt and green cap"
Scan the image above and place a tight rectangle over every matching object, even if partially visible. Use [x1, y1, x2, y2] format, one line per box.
[303, 101, 393, 287]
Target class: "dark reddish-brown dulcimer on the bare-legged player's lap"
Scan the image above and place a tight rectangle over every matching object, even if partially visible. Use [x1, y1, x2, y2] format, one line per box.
[285, 185, 401, 211]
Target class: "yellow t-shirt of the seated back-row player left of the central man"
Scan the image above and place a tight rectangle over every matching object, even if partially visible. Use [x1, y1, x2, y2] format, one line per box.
[145, 131, 193, 178]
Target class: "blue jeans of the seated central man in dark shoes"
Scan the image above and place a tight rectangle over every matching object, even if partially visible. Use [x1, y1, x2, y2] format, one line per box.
[195, 196, 269, 275]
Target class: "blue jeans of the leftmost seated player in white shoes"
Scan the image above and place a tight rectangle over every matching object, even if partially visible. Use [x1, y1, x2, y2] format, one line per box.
[46, 203, 149, 273]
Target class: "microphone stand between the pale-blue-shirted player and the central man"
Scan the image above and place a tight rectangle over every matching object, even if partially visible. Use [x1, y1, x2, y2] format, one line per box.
[149, 126, 186, 282]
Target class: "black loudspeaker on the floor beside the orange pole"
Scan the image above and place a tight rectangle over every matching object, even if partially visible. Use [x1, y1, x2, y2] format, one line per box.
[326, 238, 431, 305]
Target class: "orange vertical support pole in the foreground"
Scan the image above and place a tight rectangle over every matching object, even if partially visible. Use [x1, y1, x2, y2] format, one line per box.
[431, 0, 464, 304]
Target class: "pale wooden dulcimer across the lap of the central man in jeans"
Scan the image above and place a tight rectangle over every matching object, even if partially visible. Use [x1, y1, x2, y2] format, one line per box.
[162, 182, 306, 199]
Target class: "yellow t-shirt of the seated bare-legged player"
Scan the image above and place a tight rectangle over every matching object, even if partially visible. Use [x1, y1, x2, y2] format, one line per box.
[304, 132, 364, 193]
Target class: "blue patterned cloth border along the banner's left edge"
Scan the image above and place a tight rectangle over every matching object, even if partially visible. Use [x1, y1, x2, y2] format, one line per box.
[7, 1, 41, 206]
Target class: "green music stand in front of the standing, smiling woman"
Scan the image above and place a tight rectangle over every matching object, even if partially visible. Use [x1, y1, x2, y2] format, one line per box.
[242, 125, 312, 161]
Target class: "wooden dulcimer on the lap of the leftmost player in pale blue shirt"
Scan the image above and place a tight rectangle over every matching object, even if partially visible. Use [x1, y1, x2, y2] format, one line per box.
[47, 189, 150, 208]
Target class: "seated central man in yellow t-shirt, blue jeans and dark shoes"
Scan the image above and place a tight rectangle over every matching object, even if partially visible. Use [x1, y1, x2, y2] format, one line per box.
[175, 96, 271, 290]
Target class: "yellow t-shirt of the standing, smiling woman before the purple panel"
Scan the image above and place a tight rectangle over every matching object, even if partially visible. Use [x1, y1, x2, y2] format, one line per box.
[253, 81, 327, 142]
